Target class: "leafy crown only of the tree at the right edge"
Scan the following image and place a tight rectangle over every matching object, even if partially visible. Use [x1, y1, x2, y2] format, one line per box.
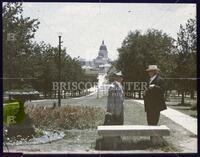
[174, 19, 197, 77]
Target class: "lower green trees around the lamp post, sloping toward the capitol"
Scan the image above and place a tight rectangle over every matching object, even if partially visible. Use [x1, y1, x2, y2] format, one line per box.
[31, 43, 87, 94]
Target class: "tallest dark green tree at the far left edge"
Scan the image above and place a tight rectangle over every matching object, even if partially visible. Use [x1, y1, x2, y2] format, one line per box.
[2, 3, 39, 89]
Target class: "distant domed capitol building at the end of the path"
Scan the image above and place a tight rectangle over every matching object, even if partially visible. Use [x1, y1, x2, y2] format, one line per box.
[79, 40, 111, 74]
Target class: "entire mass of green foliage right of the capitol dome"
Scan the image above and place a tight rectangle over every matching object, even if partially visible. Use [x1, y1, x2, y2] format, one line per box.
[115, 19, 197, 100]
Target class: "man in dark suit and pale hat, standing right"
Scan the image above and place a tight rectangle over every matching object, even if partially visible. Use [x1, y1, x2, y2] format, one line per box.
[144, 65, 167, 125]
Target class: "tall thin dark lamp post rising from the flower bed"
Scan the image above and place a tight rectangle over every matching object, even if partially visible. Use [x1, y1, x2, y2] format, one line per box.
[58, 33, 62, 107]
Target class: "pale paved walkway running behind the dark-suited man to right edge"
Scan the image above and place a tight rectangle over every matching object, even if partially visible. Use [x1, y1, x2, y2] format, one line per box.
[134, 100, 198, 135]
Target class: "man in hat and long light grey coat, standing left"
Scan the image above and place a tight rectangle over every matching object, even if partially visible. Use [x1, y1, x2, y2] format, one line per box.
[104, 71, 124, 125]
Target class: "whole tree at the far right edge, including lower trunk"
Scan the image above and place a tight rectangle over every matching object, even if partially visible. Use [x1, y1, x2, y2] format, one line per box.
[175, 19, 197, 104]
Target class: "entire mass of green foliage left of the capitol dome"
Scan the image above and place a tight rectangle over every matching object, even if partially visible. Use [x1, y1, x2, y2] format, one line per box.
[3, 3, 89, 96]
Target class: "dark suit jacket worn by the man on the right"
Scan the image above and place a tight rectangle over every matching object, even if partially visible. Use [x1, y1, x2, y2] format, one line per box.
[144, 75, 167, 112]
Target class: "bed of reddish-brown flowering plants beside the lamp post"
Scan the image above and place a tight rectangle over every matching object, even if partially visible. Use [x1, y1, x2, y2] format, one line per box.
[25, 105, 105, 129]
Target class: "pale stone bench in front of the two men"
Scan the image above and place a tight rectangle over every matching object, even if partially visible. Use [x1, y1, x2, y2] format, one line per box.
[97, 125, 170, 144]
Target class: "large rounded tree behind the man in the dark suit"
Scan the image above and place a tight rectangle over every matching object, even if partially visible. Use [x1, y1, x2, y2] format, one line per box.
[117, 29, 174, 96]
